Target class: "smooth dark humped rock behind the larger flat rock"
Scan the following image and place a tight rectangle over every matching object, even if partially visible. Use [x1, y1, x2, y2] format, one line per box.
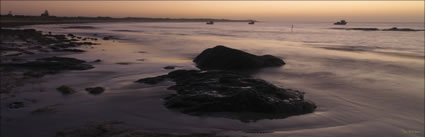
[193, 45, 285, 70]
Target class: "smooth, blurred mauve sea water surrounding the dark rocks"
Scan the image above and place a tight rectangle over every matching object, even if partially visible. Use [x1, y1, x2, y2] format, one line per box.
[6, 22, 424, 137]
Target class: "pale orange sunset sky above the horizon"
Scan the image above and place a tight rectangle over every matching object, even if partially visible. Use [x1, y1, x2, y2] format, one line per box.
[1, 0, 424, 22]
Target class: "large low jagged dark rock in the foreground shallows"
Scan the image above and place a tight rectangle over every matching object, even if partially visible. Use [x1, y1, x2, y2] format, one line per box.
[138, 70, 316, 121]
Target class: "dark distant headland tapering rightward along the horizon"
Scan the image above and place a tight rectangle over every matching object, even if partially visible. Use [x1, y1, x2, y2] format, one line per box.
[0, 10, 255, 27]
